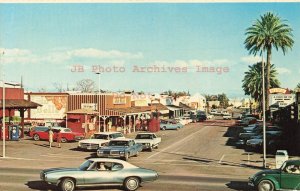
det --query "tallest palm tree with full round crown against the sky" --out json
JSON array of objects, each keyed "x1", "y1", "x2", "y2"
[{"x1": 244, "y1": 12, "x2": 294, "y2": 108}]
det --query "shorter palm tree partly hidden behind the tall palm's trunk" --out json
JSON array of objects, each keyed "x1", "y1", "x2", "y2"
[{"x1": 242, "y1": 62, "x2": 280, "y2": 109}]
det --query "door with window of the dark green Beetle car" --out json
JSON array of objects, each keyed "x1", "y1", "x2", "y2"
[{"x1": 280, "y1": 164, "x2": 300, "y2": 190}]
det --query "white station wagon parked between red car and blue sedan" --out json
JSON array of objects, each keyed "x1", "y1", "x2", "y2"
[{"x1": 78, "y1": 132, "x2": 125, "y2": 150}]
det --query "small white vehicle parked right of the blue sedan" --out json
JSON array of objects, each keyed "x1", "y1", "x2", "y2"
[{"x1": 135, "y1": 133, "x2": 161, "y2": 152}]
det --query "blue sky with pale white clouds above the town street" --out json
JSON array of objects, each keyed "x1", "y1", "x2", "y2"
[{"x1": 0, "y1": 3, "x2": 300, "y2": 97}]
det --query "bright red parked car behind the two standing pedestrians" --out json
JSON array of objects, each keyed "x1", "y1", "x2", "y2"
[{"x1": 29, "y1": 126, "x2": 84, "y2": 143}]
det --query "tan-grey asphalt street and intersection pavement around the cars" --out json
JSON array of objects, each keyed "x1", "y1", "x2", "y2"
[{"x1": 0, "y1": 120, "x2": 260, "y2": 191}]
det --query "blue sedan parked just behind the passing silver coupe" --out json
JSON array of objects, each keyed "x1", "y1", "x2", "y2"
[{"x1": 97, "y1": 139, "x2": 143, "y2": 161}]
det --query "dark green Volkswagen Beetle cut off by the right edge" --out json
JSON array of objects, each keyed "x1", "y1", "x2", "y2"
[{"x1": 248, "y1": 160, "x2": 300, "y2": 191}]
